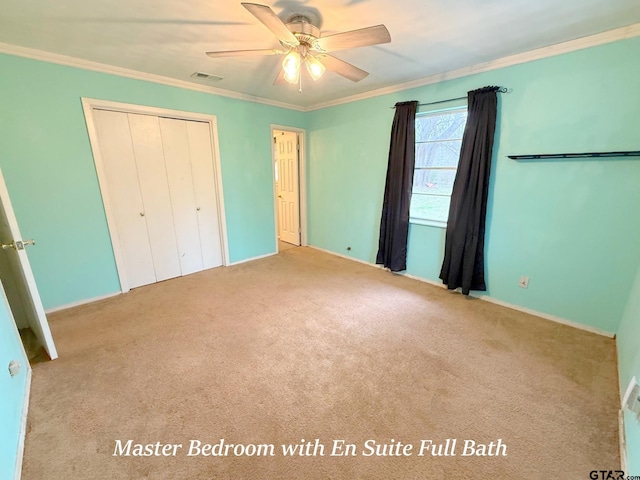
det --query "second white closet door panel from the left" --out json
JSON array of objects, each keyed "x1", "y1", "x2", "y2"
[{"x1": 129, "y1": 113, "x2": 181, "y2": 281}]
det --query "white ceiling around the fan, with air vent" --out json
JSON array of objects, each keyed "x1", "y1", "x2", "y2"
[{"x1": 0, "y1": 0, "x2": 640, "y2": 108}]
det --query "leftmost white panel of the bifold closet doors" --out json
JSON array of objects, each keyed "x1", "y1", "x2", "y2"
[{"x1": 94, "y1": 110, "x2": 156, "y2": 288}]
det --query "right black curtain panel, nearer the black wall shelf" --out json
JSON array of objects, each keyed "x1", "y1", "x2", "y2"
[{"x1": 440, "y1": 87, "x2": 499, "y2": 295}]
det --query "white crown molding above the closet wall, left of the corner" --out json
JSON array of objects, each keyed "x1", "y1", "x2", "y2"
[{"x1": 0, "y1": 42, "x2": 306, "y2": 112}]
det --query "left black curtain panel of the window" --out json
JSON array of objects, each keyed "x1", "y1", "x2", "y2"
[{"x1": 376, "y1": 101, "x2": 418, "y2": 272}]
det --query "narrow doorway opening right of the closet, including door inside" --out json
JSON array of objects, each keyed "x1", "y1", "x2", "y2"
[{"x1": 271, "y1": 125, "x2": 307, "y2": 252}]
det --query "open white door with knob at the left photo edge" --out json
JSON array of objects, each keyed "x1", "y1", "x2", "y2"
[{"x1": 0, "y1": 167, "x2": 58, "y2": 360}]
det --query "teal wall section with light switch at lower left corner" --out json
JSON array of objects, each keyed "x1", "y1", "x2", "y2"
[{"x1": 0, "y1": 287, "x2": 29, "y2": 479}]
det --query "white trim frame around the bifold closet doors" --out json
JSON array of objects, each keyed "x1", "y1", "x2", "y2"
[{"x1": 82, "y1": 97, "x2": 229, "y2": 293}]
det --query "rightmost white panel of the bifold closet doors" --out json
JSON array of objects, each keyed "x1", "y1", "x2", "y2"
[{"x1": 186, "y1": 122, "x2": 222, "y2": 268}]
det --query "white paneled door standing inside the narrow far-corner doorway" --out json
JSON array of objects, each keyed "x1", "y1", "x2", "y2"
[{"x1": 275, "y1": 131, "x2": 300, "y2": 245}]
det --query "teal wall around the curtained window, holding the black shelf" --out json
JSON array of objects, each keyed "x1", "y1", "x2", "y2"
[{"x1": 308, "y1": 38, "x2": 640, "y2": 333}]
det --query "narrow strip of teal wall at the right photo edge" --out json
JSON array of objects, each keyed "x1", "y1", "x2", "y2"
[{"x1": 617, "y1": 268, "x2": 640, "y2": 475}]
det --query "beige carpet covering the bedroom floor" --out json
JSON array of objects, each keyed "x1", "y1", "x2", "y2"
[{"x1": 23, "y1": 248, "x2": 620, "y2": 480}]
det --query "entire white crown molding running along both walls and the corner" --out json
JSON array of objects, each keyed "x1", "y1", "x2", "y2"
[{"x1": 0, "y1": 23, "x2": 640, "y2": 112}]
